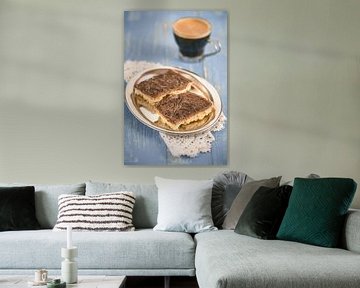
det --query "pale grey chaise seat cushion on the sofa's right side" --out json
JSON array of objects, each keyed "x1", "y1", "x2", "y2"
[{"x1": 195, "y1": 230, "x2": 360, "y2": 288}]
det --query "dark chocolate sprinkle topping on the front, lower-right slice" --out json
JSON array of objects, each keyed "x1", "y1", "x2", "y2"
[{"x1": 156, "y1": 92, "x2": 212, "y2": 124}]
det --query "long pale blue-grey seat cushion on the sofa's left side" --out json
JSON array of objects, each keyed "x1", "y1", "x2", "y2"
[{"x1": 0, "y1": 229, "x2": 195, "y2": 270}]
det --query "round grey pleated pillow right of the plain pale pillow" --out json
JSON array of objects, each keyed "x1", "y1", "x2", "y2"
[{"x1": 211, "y1": 171, "x2": 250, "y2": 228}]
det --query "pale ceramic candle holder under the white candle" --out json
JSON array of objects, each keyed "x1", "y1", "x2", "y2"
[{"x1": 61, "y1": 247, "x2": 78, "y2": 284}]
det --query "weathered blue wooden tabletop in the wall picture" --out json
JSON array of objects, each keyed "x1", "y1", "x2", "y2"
[{"x1": 124, "y1": 10, "x2": 228, "y2": 165}]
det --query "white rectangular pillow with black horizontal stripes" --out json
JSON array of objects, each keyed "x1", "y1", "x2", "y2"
[{"x1": 54, "y1": 192, "x2": 135, "y2": 231}]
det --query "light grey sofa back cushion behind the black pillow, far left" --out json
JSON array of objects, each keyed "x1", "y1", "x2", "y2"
[{"x1": 0, "y1": 183, "x2": 85, "y2": 229}]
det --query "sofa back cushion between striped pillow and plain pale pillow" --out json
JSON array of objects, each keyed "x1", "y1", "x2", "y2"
[{"x1": 85, "y1": 181, "x2": 158, "y2": 229}]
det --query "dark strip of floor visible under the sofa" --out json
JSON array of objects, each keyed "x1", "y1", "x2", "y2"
[{"x1": 126, "y1": 276, "x2": 199, "y2": 288}]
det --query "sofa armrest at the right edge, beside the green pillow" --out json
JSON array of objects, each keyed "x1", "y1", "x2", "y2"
[{"x1": 342, "y1": 209, "x2": 360, "y2": 253}]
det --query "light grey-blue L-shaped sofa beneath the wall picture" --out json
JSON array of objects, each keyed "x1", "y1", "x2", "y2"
[{"x1": 0, "y1": 173, "x2": 360, "y2": 288}]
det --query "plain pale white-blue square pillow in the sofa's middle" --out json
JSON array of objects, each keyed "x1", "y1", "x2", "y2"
[{"x1": 154, "y1": 177, "x2": 216, "y2": 233}]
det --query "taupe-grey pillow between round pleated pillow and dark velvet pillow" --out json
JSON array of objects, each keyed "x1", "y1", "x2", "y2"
[{"x1": 223, "y1": 176, "x2": 281, "y2": 230}]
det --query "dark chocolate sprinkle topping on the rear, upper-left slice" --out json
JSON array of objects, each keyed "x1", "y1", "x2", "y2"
[{"x1": 135, "y1": 70, "x2": 191, "y2": 98}]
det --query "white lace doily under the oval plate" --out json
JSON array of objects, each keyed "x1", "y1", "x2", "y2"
[{"x1": 124, "y1": 60, "x2": 226, "y2": 157}]
